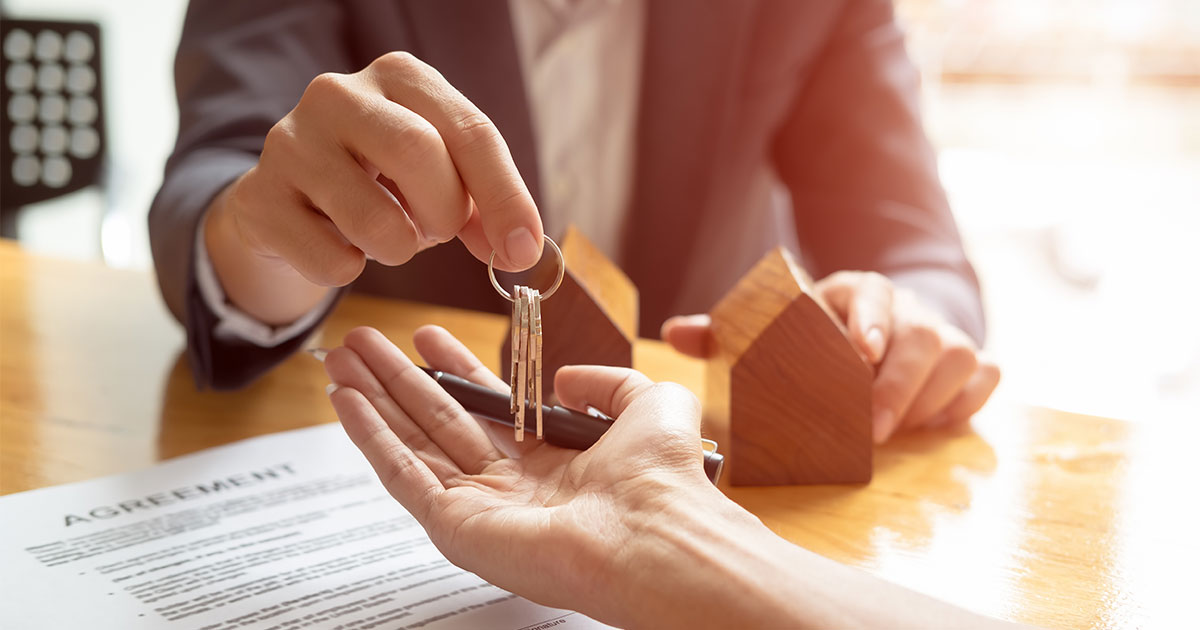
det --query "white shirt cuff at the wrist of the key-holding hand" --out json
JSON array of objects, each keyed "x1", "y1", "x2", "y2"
[{"x1": 194, "y1": 215, "x2": 337, "y2": 348}]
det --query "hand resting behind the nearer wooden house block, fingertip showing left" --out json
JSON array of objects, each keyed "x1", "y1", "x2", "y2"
[{"x1": 662, "y1": 271, "x2": 1000, "y2": 443}]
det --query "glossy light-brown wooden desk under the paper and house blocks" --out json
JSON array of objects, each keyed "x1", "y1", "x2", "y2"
[{"x1": 0, "y1": 242, "x2": 1200, "y2": 628}]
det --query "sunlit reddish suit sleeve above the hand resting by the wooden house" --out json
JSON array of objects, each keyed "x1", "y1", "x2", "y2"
[{"x1": 774, "y1": 0, "x2": 984, "y2": 343}]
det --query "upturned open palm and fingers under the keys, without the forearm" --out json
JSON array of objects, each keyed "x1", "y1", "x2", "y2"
[{"x1": 325, "y1": 326, "x2": 720, "y2": 619}]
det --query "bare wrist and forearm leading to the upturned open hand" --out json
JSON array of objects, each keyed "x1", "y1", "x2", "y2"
[{"x1": 595, "y1": 487, "x2": 1001, "y2": 628}]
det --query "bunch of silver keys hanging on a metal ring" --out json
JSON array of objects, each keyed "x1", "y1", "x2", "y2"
[{"x1": 487, "y1": 236, "x2": 566, "y2": 442}]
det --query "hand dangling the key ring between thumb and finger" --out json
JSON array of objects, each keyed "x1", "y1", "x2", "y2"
[{"x1": 205, "y1": 53, "x2": 542, "y2": 323}]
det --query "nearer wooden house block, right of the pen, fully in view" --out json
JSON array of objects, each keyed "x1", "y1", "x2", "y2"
[{"x1": 706, "y1": 247, "x2": 874, "y2": 486}]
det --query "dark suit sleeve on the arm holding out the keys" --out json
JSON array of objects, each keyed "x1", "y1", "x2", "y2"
[{"x1": 149, "y1": 0, "x2": 350, "y2": 389}]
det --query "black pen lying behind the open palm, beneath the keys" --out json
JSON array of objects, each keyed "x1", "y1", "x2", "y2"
[{"x1": 307, "y1": 348, "x2": 725, "y2": 484}]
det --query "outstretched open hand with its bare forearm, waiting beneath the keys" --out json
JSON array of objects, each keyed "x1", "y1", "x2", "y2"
[{"x1": 325, "y1": 326, "x2": 1012, "y2": 628}]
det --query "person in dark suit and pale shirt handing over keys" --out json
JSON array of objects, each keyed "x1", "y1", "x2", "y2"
[{"x1": 150, "y1": 0, "x2": 1000, "y2": 440}]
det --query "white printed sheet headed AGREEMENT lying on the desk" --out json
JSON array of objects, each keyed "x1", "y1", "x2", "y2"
[{"x1": 0, "y1": 424, "x2": 606, "y2": 630}]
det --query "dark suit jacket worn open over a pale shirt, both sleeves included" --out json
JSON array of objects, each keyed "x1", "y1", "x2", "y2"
[{"x1": 150, "y1": 0, "x2": 983, "y2": 388}]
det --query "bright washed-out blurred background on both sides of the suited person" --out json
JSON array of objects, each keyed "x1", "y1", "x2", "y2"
[{"x1": 2, "y1": 0, "x2": 1200, "y2": 421}]
